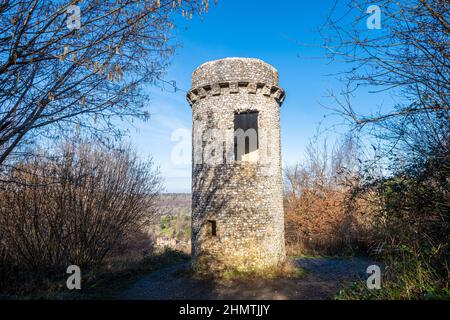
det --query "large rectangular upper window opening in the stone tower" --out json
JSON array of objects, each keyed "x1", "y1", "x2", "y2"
[{"x1": 234, "y1": 112, "x2": 259, "y2": 161}]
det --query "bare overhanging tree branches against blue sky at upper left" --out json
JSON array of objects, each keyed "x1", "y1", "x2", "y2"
[{"x1": 0, "y1": 0, "x2": 208, "y2": 165}]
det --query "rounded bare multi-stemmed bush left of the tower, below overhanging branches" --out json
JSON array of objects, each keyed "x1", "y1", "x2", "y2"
[{"x1": 0, "y1": 140, "x2": 161, "y2": 275}]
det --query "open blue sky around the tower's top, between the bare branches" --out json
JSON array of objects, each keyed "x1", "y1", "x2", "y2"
[{"x1": 124, "y1": 0, "x2": 390, "y2": 192}]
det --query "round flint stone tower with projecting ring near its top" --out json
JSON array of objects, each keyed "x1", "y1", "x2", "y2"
[{"x1": 187, "y1": 58, "x2": 285, "y2": 271}]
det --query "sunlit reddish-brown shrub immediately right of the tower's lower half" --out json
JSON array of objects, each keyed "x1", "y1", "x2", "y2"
[{"x1": 285, "y1": 139, "x2": 372, "y2": 255}]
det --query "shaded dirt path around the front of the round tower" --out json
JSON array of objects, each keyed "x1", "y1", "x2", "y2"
[{"x1": 117, "y1": 258, "x2": 374, "y2": 300}]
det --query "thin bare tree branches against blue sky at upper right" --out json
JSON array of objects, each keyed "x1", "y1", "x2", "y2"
[{"x1": 321, "y1": 0, "x2": 450, "y2": 157}]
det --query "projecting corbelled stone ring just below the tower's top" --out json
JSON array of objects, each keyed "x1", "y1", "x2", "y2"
[{"x1": 186, "y1": 81, "x2": 286, "y2": 106}]
